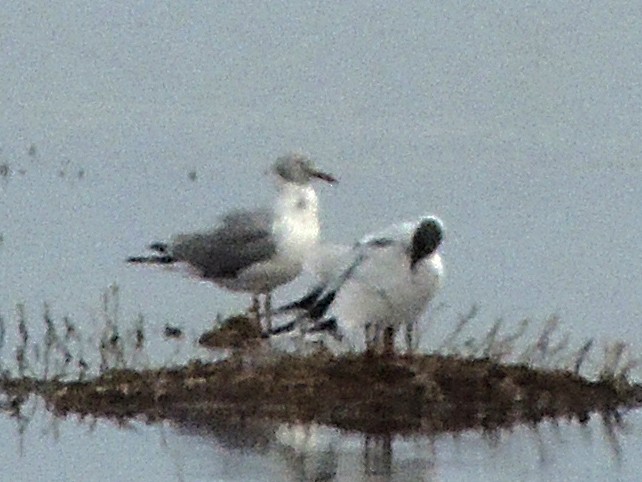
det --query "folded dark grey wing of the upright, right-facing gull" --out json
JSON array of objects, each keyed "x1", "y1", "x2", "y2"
[{"x1": 171, "y1": 209, "x2": 277, "y2": 279}]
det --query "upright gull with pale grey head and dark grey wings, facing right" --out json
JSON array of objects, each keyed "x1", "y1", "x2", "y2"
[{"x1": 127, "y1": 154, "x2": 337, "y2": 330}]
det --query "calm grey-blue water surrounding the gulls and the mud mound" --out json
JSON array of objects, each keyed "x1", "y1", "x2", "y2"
[{"x1": 0, "y1": 2, "x2": 642, "y2": 480}]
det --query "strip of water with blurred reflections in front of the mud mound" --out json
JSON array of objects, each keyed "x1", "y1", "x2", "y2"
[{"x1": 0, "y1": 397, "x2": 642, "y2": 482}]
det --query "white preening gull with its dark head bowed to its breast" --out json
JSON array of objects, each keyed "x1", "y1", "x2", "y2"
[{"x1": 271, "y1": 216, "x2": 444, "y2": 353}]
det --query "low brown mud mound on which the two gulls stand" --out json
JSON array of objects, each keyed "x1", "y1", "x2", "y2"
[{"x1": 20, "y1": 354, "x2": 642, "y2": 433}]
